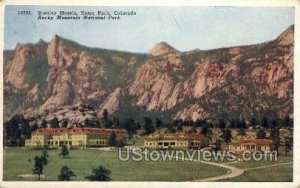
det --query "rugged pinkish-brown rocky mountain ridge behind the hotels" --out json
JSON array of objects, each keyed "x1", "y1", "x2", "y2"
[{"x1": 3, "y1": 26, "x2": 294, "y2": 128}]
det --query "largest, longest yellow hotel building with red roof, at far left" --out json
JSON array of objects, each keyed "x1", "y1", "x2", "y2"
[{"x1": 25, "y1": 128, "x2": 127, "y2": 148}]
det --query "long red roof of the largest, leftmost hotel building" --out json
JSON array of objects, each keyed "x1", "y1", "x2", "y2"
[{"x1": 33, "y1": 128, "x2": 126, "y2": 134}]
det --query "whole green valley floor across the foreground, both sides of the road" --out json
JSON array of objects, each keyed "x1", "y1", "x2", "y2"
[{"x1": 3, "y1": 148, "x2": 293, "y2": 182}]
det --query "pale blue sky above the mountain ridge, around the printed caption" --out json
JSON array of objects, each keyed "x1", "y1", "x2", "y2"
[{"x1": 4, "y1": 6, "x2": 294, "y2": 53}]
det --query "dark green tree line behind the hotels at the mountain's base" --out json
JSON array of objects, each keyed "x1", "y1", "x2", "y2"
[{"x1": 4, "y1": 109, "x2": 293, "y2": 146}]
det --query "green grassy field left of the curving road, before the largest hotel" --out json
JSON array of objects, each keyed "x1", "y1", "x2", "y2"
[{"x1": 3, "y1": 148, "x2": 227, "y2": 181}]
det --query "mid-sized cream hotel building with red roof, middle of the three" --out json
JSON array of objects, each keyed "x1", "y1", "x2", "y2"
[{"x1": 144, "y1": 133, "x2": 209, "y2": 149}]
